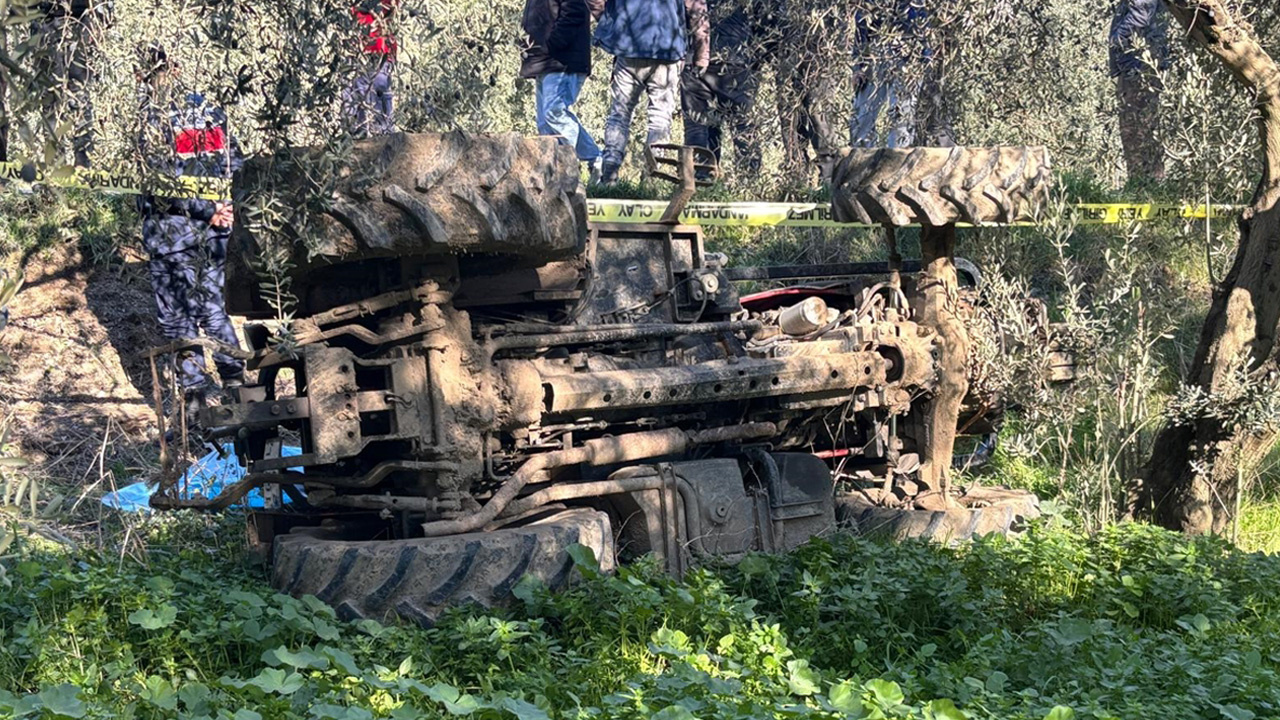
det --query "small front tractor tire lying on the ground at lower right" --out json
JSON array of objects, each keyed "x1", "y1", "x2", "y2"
[{"x1": 836, "y1": 491, "x2": 1041, "y2": 544}]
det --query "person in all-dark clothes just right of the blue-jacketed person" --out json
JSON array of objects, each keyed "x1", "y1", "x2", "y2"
[{"x1": 680, "y1": 0, "x2": 768, "y2": 173}]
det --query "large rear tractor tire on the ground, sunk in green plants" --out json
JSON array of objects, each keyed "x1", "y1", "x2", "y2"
[{"x1": 271, "y1": 509, "x2": 614, "y2": 625}]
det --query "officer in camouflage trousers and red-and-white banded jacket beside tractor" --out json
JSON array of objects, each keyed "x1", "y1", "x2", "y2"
[{"x1": 138, "y1": 46, "x2": 244, "y2": 407}]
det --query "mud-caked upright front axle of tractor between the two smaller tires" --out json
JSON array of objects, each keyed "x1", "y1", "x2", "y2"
[{"x1": 916, "y1": 225, "x2": 969, "y2": 510}]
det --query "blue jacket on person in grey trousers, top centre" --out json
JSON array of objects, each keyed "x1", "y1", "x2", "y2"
[{"x1": 595, "y1": 0, "x2": 710, "y2": 68}]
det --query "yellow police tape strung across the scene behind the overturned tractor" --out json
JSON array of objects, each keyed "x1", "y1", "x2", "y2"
[{"x1": 0, "y1": 163, "x2": 1239, "y2": 228}]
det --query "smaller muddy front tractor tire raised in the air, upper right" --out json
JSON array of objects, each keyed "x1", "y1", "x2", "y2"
[{"x1": 831, "y1": 146, "x2": 1051, "y2": 225}]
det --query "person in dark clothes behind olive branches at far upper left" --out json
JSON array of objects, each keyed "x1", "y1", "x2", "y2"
[{"x1": 32, "y1": 0, "x2": 111, "y2": 168}]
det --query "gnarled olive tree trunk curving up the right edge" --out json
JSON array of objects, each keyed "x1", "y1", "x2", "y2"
[{"x1": 1132, "y1": 0, "x2": 1280, "y2": 533}]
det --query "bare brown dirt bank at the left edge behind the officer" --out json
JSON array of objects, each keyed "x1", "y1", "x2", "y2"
[{"x1": 0, "y1": 241, "x2": 160, "y2": 481}]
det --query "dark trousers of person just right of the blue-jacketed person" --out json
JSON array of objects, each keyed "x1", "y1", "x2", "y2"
[{"x1": 680, "y1": 63, "x2": 762, "y2": 173}]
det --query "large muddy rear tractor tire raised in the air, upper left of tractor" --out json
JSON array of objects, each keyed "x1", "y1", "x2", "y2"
[{"x1": 227, "y1": 132, "x2": 588, "y2": 303}]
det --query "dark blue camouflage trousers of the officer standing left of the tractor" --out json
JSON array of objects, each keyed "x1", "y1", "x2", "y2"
[{"x1": 148, "y1": 229, "x2": 244, "y2": 389}]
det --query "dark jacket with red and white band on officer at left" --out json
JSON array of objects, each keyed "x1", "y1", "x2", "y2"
[{"x1": 138, "y1": 92, "x2": 243, "y2": 255}]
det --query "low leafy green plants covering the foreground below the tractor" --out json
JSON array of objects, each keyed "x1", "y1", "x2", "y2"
[{"x1": 0, "y1": 516, "x2": 1280, "y2": 720}]
